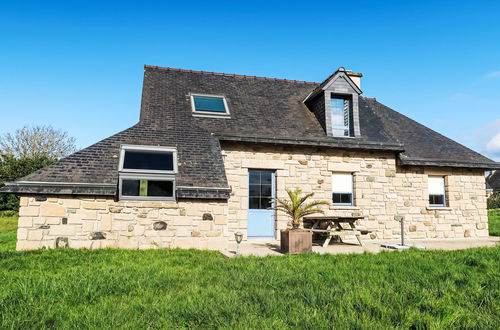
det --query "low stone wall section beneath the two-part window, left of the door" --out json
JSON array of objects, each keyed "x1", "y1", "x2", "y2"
[{"x1": 17, "y1": 196, "x2": 229, "y2": 250}]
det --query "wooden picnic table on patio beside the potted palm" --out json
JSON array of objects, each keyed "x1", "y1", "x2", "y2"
[{"x1": 304, "y1": 216, "x2": 364, "y2": 247}]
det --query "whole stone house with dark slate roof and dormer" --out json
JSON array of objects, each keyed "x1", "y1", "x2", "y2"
[{"x1": 1, "y1": 66, "x2": 500, "y2": 250}]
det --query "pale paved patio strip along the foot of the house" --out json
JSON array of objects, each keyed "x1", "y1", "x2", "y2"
[{"x1": 221, "y1": 236, "x2": 500, "y2": 257}]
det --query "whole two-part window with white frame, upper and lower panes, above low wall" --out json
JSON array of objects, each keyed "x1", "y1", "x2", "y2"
[{"x1": 119, "y1": 145, "x2": 177, "y2": 200}]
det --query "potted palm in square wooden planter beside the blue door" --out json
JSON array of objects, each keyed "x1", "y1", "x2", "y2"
[{"x1": 276, "y1": 188, "x2": 330, "y2": 253}]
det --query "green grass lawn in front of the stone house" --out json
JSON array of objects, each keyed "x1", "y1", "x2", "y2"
[{"x1": 0, "y1": 214, "x2": 500, "y2": 329}]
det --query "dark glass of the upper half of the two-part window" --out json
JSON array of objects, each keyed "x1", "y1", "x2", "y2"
[{"x1": 123, "y1": 150, "x2": 174, "y2": 171}]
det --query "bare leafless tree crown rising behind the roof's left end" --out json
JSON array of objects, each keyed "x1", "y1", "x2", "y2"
[{"x1": 0, "y1": 126, "x2": 76, "y2": 159}]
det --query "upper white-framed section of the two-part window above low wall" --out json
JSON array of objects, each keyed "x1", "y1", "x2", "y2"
[{"x1": 120, "y1": 145, "x2": 177, "y2": 174}]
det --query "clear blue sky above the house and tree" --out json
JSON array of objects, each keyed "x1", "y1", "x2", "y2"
[{"x1": 0, "y1": 0, "x2": 500, "y2": 160}]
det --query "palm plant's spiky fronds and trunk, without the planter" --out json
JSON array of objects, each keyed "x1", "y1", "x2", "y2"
[{"x1": 276, "y1": 188, "x2": 330, "y2": 229}]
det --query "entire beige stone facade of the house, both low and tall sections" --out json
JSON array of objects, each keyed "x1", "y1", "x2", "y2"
[{"x1": 17, "y1": 144, "x2": 488, "y2": 249}]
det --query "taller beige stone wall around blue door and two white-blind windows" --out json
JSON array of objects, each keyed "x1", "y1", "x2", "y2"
[{"x1": 223, "y1": 144, "x2": 488, "y2": 239}]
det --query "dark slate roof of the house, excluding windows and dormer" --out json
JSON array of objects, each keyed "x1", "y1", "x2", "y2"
[{"x1": 1, "y1": 66, "x2": 500, "y2": 198}]
